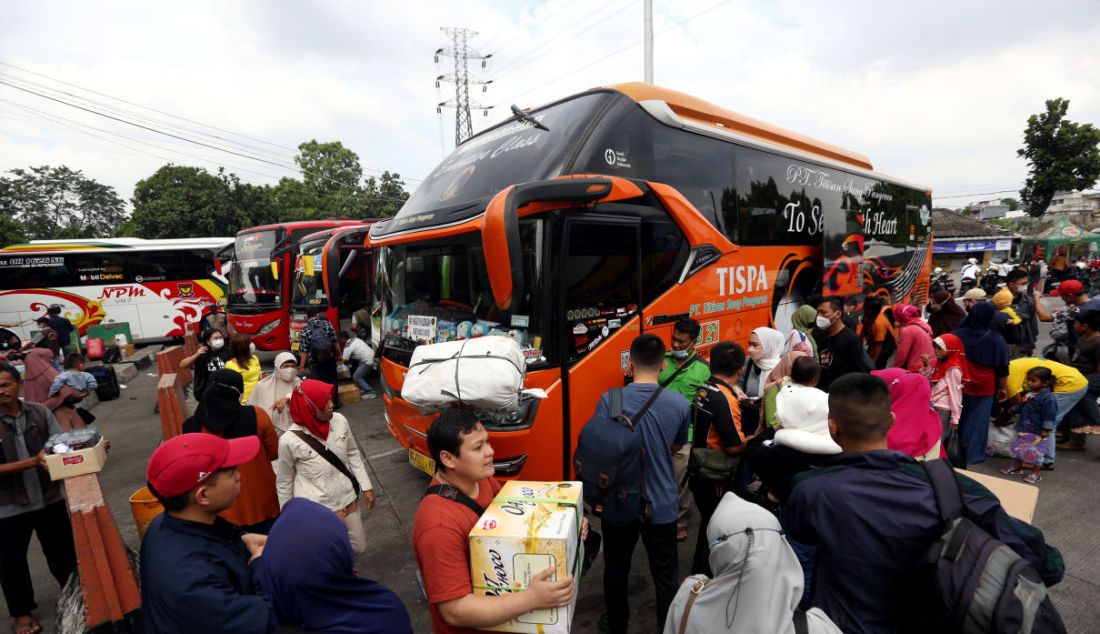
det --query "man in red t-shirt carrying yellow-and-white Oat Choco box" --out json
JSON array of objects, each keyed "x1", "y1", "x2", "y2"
[{"x1": 413, "y1": 409, "x2": 587, "y2": 634}]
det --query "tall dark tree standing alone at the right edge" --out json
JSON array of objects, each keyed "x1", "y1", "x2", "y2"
[{"x1": 1016, "y1": 98, "x2": 1100, "y2": 217}]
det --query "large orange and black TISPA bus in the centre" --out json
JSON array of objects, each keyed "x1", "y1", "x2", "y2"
[{"x1": 370, "y1": 84, "x2": 932, "y2": 480}]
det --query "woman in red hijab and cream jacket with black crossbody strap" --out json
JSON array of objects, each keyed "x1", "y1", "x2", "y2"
[{"x1": 275, "y1": 379, "x2": 374, "y2": 556}]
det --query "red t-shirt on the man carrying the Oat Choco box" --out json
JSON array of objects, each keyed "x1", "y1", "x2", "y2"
[{"x1": 413, "y1": 478, "x2": 502, "y2": 634}]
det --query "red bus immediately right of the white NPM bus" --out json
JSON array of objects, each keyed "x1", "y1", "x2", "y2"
[{"x1": 226, "y1": 219, "x2": 363, "y2": 350}]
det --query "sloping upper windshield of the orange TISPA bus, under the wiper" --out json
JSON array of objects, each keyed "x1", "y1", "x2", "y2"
[{"x1": 389, "y1": 92, "x2": 613, "y2": 222}]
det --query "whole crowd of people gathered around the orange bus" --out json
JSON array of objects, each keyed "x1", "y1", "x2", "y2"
[{"x1": 0, "y1": 278, "x2": 1082, "y2": 634}]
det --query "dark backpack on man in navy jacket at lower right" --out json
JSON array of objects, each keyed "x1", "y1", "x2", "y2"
[{"x1": 908, "y1": 460, "x2": 1066, "y2": 634}]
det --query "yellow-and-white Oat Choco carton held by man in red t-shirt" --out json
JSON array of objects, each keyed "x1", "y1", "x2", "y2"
[{"x1": 470, "y1": 481, "x2": 584, "y2": 634}]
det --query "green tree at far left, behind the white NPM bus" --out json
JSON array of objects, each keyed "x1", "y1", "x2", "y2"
[{"x1": 0, "y1": 165, "x2": 127, "y2": 240}]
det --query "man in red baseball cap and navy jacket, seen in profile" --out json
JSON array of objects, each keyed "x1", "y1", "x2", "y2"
[{"x1": 141, "y1": 434, "x2": 278, "y2": 634}]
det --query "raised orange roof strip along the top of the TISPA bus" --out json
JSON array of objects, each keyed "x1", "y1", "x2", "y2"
[{"x1": 608, "y1": 81, "x2": 875, "y2": 171}]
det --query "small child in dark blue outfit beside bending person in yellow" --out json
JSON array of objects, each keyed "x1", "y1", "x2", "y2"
[{"x1": 1001, "y1": 368, "x2": 1058, "y2": 484}]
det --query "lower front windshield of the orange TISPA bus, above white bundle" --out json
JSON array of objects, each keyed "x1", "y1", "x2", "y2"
[{"x1": 376, "y1": 220, "x2": 542, "y2": 358}]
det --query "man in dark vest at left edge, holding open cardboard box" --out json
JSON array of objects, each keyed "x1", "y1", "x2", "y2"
[{"x1": 0, "y1": 363, "x2": 76, "y2": 634}]
